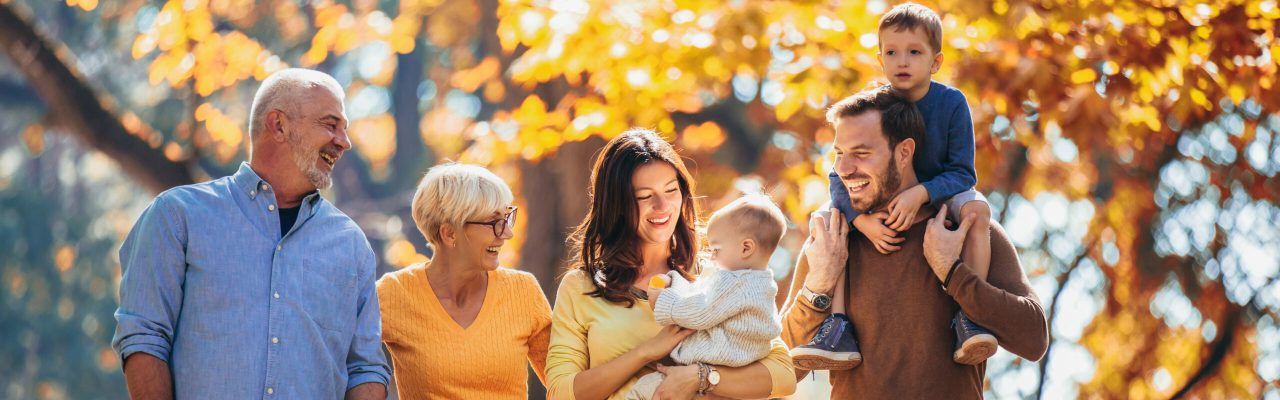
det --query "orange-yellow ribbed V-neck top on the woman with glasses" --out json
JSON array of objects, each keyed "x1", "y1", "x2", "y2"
[{"x1": 378, "y1": 263, "x2": 552, "y2": 399}]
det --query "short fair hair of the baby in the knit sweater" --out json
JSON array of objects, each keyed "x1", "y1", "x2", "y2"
[{"x1": 707, "y1": 194, "x2": 787, "y2": 254}]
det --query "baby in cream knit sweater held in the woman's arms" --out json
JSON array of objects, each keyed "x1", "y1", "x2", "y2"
[{"x1": 626, "y1": 195, "x2": 786, "y2": 399}]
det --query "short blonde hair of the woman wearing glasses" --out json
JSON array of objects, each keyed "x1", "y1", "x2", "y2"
[{"x1": 413, "y1": 163, "x2": 513, "y2": 246}]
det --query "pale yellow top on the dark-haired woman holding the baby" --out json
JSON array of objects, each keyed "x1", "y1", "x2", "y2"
[{"x1": 547, "y1": 269, "x2": 796, "y2": 400}]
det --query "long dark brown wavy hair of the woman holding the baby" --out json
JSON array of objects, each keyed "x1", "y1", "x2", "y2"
[{"x1": 570, "y1": 128, "x2": 699, "y2": 308}]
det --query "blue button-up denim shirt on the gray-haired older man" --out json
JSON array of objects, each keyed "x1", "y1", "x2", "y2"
[{"x1": 111, "y1": 163, "x2": 389, "y2": 399}]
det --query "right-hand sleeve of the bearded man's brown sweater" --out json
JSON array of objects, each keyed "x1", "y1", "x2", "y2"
[{"x1": 942, "y1": 222, "x2": 1048, "y2": 362}]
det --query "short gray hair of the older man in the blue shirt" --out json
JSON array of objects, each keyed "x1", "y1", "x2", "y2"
[{"x1": 248, "y1": 68, "x2": 344, "y2": 138}]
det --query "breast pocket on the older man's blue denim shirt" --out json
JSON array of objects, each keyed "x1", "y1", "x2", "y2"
[{"x1": 294, "y1": 256, "x2": 357, "y2": 332}]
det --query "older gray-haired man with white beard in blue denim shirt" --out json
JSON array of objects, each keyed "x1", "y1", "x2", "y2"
[{"x1": 113, "y1": 69, "x2": 389, "y2": 399}]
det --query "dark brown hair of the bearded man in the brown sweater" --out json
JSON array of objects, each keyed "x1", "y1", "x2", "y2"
[{"x1": 827, "y1": 85, "x2": 924, "y2": 153}]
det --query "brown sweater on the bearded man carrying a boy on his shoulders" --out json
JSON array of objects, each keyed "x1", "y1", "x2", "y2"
[{"x1": 782, "y1": 222, "x2": 1048, "y2": 399}]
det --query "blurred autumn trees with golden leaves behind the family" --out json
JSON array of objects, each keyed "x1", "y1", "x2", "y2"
[{"x1": 0, "y1": 0, "x2": 1280, "y2": 399}]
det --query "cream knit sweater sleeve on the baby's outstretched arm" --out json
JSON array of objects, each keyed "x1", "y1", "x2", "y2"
[{"x1": 653, "y1": 273, "x2": 753, "y2": 331}]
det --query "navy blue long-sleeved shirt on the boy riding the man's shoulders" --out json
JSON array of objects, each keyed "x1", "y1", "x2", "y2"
[{"x1": 827, "y1": 82, "x2": 978, "y2": 222}]
